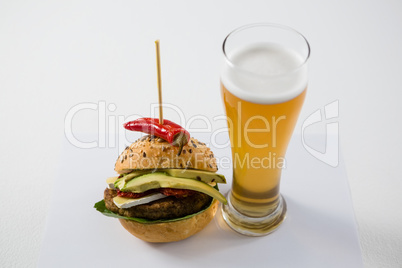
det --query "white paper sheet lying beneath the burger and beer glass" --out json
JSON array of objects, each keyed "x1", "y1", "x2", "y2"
[{"x1": 38, "y1": 133, "x2": 363, "y2": 268}]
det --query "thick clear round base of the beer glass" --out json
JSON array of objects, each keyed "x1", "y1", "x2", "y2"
[{"x1": 222, "y1": 192, "x2": 286, "y2": 236}]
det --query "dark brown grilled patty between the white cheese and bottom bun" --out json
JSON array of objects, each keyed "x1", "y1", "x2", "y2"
[{"x1": 104, "y1": 188, "x2": 212, "y2": 220}]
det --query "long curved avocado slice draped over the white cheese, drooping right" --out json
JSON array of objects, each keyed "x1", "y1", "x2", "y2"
[{"x1": 121, "y1": 172, "x2": 227, "y2": 204}]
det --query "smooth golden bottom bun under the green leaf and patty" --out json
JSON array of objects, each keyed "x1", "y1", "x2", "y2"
[{"x1": 119, "y1": 199, "x2": 219, "y2": 243}]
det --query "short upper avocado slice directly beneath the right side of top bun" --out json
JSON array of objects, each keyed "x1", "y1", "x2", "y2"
[{"x1": 163, "y1": 169, "x2": 226, "y2": 183}]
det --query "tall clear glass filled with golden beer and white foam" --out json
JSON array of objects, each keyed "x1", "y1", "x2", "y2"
[{"x1": 221, "y1": 23, "x2": 310, "y2": 236}]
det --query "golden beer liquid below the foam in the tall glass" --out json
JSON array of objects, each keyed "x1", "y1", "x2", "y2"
[{"x1": 221, "y1": 84, "x2": 306, "y2": 217}]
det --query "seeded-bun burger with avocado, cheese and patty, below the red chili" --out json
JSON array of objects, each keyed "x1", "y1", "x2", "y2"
[{"x1": 95, "y1": 135, "x2": 227, "y2": 242}]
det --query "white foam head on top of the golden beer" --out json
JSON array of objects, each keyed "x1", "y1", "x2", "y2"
[{"x1": 221, "y1": 43, "x2": 307, "y2": 104}]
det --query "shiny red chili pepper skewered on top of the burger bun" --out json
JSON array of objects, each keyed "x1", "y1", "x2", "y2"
[{"x1": 123, "y1": 118, "x2": 190, "y2": 155}]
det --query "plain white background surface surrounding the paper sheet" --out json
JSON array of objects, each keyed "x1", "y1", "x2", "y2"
[{"x1": 0, "y1": 0, "x2": 402, "y2": 267}]
